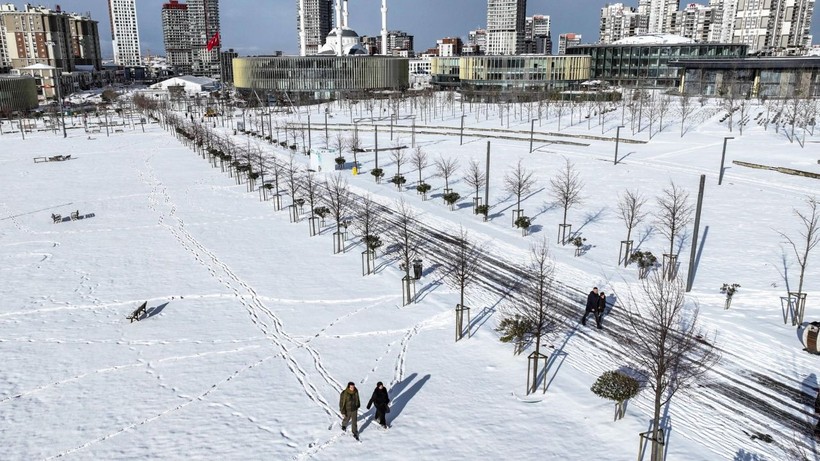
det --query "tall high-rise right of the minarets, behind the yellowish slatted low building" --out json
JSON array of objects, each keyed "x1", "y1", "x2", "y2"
[{"x1": 486, "y1": 0, "x2": 527, "y2": 55}]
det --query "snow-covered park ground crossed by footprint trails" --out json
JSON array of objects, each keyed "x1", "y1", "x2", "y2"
[{"x1": 0, "y1": 94, "x2": 820, "y2": 460}]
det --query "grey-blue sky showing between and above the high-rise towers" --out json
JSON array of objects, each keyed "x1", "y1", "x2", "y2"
[{"x1": 43, "y1": 0, "x2": 820, "y2": 58}]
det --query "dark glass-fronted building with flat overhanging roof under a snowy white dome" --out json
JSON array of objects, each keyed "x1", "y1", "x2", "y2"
[{"x1": 567, "y1": 43, "x2": 748, "y2": 88}]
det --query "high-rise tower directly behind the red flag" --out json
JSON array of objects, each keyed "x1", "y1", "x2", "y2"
[{"x1": 188, "y1": 0, "x2": 222, "y2": 79}]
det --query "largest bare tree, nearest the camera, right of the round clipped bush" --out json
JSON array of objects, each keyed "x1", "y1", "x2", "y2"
[{"x1": 620, "y1": 272, "x2": 720, "y2": 461}]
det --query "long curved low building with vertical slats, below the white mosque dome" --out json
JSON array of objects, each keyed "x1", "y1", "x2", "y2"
[{"x1": 233, "y1": 56, "x2": 410, "y2": 101}]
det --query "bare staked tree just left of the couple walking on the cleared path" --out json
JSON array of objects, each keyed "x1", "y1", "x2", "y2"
[{"x1": 497, "y1": 240, "x2": 565, "y2": 393}]
